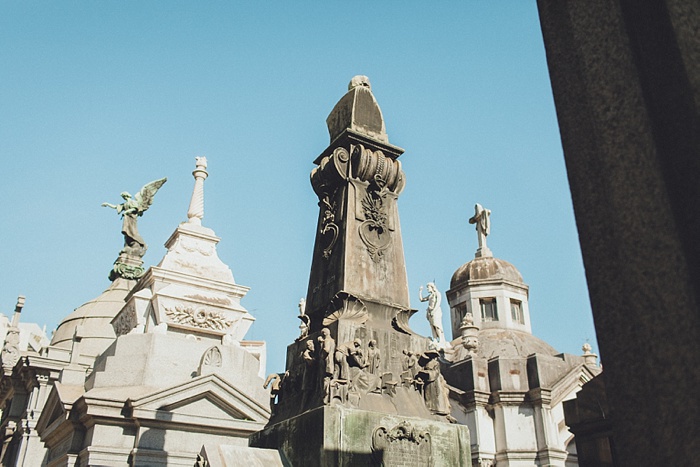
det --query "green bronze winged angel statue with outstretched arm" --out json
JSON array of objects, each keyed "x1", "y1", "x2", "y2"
[{"x1": 102, "y1": 178, "x2": 168, "y2": 257}]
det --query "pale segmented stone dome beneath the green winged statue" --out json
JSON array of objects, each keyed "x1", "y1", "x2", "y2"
[{"x1": 51, "y1": 277, "x2": 136, "y2": 356}]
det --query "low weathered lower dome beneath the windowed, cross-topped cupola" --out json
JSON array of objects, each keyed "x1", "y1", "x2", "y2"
[{"x1": 478, "y1": 329, "x2": 561, "y2": 358}]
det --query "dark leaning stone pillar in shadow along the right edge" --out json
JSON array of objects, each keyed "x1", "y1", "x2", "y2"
[{"x1": 538, "y1": 0, "x2": 700, "y2": 465}]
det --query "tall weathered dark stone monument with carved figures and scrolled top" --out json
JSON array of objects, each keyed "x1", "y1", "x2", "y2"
[{"x1": 250, "y1": 76, "x2": 471, "y2": 466}]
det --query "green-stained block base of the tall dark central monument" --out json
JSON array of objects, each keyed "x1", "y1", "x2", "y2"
[{"x1": 249, "y1": 406, "x2": 471, "y2": 467}]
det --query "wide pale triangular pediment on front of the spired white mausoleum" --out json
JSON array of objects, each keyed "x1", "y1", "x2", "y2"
[{"x1": 127, "y1": 374, "x2": 270, "y2": 425}]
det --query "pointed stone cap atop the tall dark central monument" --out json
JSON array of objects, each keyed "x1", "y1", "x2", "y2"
[{"x1": 326, "y1": 75, "x2": 389, "y2": 143}]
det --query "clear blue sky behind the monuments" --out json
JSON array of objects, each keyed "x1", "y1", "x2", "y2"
[{"x1": 0, "y1": 0, "x2": 597, "y2": 371}]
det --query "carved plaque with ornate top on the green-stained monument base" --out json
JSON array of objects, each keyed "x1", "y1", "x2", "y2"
[{"x1": 372, "y1": 421, "x2": 433, "y2": 467}]
